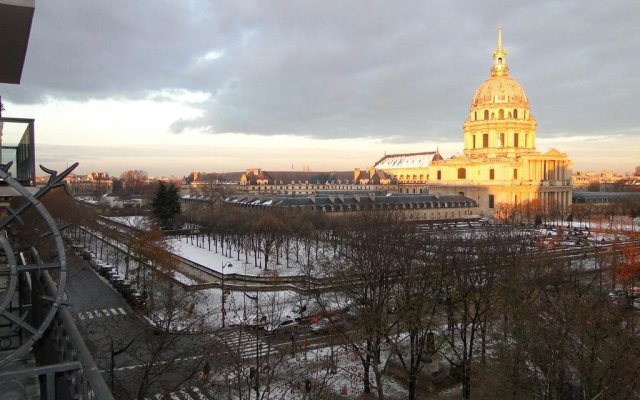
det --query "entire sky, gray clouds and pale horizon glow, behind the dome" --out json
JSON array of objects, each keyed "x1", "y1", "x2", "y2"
[{"x1": 0, "y1": 0, "x2": 640, "y2": 176}]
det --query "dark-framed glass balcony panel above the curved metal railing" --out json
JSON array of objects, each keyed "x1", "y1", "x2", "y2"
[{"x1": 0, "y1": 117, "x2": 36, "y2": 186}]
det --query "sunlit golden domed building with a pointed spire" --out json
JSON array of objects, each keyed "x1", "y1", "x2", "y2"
[{"x1": 374, "y1": 28, "x2": 571, "y2": 216}]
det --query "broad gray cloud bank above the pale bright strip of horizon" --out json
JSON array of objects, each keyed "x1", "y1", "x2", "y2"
[{"x1": 0, "y1": 0, "x2": 640, "y2": 141}]
